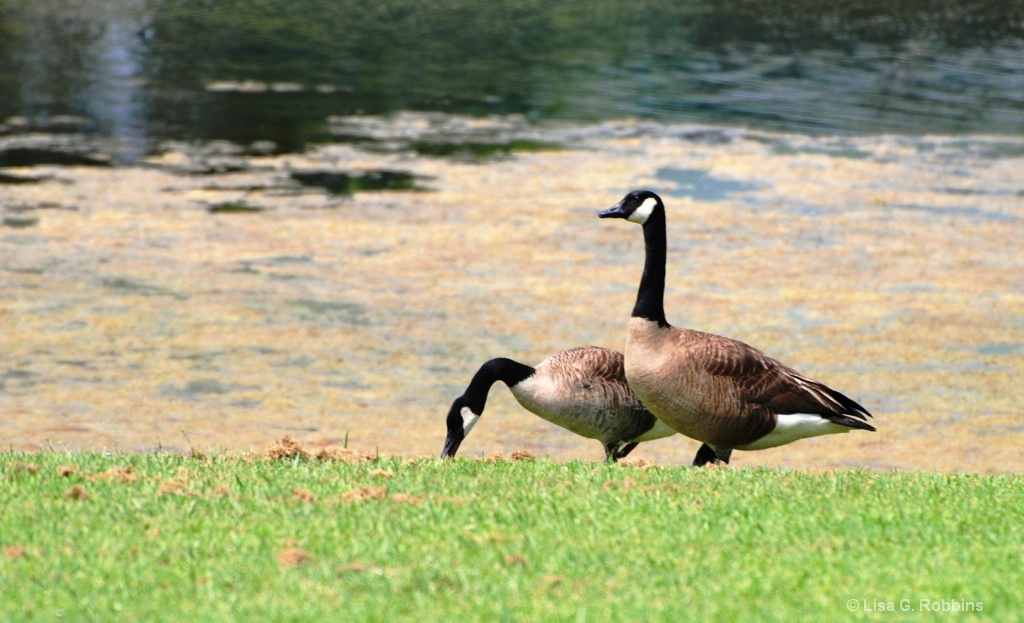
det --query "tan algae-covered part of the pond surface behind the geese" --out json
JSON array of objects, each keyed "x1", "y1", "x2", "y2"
[{"x1": 0, "y1": 120, "x2": 1024, "y2": 472}]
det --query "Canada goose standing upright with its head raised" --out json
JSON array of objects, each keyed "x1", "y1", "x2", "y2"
[{"x1": 599, "y1": 191, "x2": 874, "y2": 463}]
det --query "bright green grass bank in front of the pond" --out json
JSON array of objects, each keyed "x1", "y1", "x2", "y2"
[{"x1": 0, "y1": 452, "x2": 1024, "y2": 621}]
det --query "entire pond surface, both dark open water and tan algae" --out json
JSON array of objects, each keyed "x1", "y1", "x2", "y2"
[{"x1": 0, "y1": 0, "x2": 1024, "y2": 471}]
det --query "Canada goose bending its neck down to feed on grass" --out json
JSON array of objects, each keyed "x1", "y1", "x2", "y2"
[{"x1": 441, "y1": 346, "x2": 714, "y2": 464}]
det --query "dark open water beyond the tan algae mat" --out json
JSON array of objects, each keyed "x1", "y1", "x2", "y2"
[{"x1": 0, "y1": 0, "x2": 1024, "y2": 160}]
